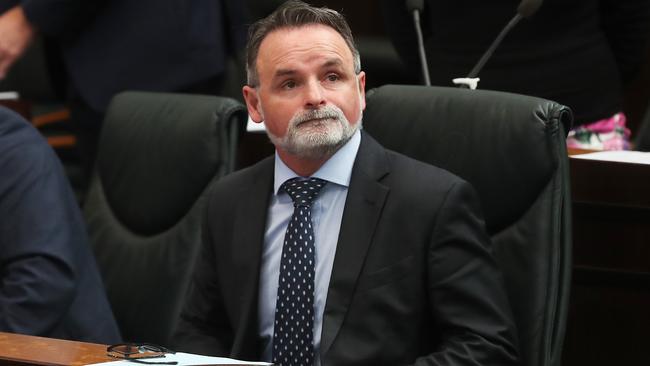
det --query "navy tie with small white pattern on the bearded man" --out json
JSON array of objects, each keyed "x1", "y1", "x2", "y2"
[{"x1": 273, "y1": 178, "x2": 327, "y2": 366}]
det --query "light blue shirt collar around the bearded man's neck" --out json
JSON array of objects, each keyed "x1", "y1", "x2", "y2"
[{"x1": 273, "y1": 130, "x2": 361, "y2": 194}]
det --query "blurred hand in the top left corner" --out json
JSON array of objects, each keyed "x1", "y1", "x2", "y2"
[{"x1": 0, "y1": 5, "x2": 35, "y2": 79}]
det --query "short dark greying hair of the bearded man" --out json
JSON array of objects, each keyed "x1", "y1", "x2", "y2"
[{"x1": 246, "y1": 0, "x2": 361, "y2": 87}]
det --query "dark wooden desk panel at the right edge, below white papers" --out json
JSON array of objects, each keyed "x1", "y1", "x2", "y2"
[{"x1": 563, "y1": 158, "x2": 650, "y2": 366}]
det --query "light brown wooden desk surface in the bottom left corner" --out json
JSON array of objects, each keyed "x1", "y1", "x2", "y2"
[{"x1": 0, "y1": 332, "x2": 110, "y2": 366}]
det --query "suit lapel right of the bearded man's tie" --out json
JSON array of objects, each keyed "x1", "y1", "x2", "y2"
[{"x1": 320, "y1": 133, "x2": 389, "y2": 359}]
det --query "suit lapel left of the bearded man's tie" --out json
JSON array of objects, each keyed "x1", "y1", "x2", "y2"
[{"x1": 230, "y1": 158, "x2": 273, "y2": 358}]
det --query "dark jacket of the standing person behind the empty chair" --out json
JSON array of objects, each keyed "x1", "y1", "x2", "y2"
[{"x1": 0, "y1": 0, "x2": 245, "y2": 112}]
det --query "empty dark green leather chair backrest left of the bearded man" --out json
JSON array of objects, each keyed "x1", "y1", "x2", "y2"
[{"x1": 84, "y1": 92, "x2": 246, "y2": 345}]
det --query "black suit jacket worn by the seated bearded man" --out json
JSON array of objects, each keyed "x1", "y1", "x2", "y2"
[{"x1": 177, "y1": 133, "x2": 517, "y2": 365}]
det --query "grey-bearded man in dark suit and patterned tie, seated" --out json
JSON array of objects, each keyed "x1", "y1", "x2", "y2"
[{"x1": 176, "y1": 1, "x2": 517, "y2": 366}]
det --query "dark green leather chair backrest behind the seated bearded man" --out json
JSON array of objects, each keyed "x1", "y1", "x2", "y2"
[{"x1": 363, "y1": 85, "x2": 572, "y2": 366}]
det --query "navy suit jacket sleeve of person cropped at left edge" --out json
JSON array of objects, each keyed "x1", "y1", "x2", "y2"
[{"x1": 0, "y1": 107, "x2": 120, "y2": 344}]
